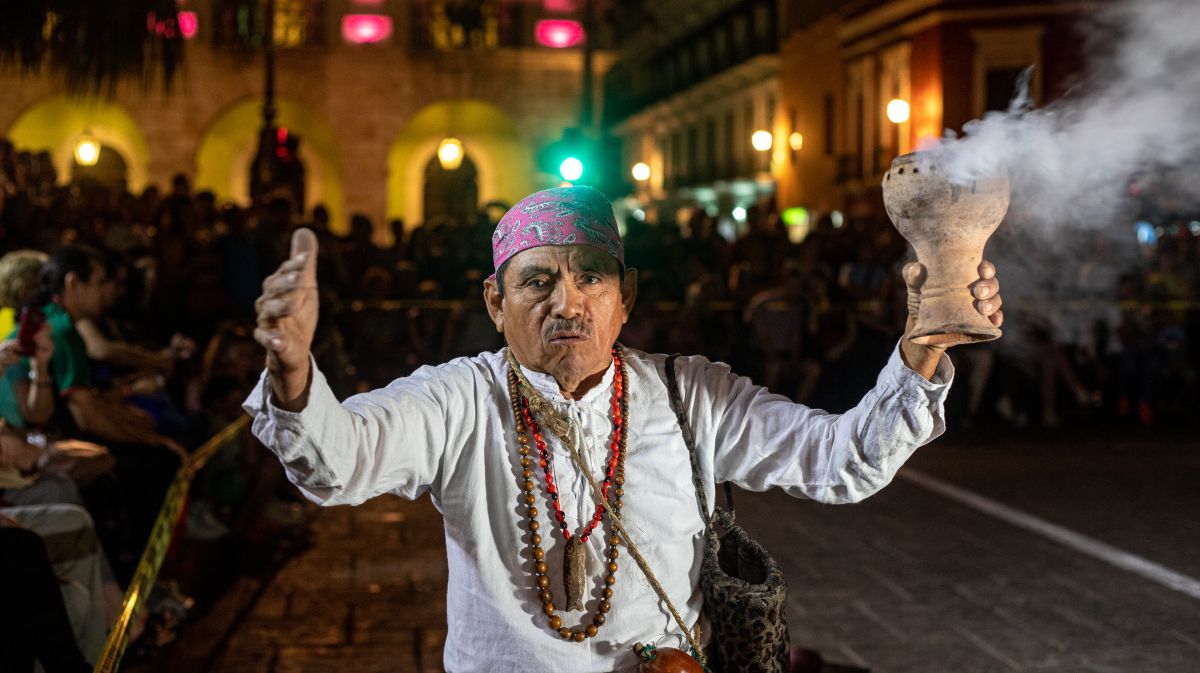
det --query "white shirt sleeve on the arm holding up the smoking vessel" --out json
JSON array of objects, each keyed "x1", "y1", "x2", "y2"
[{"x1": 679, "y1": 345, "x2": 954, "y2": 504}]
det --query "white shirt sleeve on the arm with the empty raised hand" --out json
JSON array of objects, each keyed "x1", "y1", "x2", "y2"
[{"x1": 242, "y1": 361, "x2": 475, "y2": 505}]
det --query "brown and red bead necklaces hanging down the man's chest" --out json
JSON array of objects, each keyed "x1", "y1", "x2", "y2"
[{"x1": 509, "y1": 345, "x2": 629, "y2": 643}]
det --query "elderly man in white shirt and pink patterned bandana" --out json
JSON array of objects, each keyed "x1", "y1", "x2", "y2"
[{"x1": 245, "y1": 187, "x2": 1002, "y2": 673}]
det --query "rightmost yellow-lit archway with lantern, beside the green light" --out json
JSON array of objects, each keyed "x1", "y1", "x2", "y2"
[{"x1": 388, "y1": 100, "x2": 535, "y2": 229}]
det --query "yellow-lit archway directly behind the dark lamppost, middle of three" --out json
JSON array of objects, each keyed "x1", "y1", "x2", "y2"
[{"x1": 196, "y1": 97, "x2": 348, "y2": 232}]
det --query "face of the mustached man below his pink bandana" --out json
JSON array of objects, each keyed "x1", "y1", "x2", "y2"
[{"x1": 484, "y1": 246, "x2": 637, "y2": 392}]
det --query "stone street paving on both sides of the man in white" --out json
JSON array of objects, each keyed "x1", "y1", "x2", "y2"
[{"x1": 212, "y1": 431, "x2": 1200, "y2": 673}]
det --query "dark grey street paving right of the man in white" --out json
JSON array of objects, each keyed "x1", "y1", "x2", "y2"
[{"x1": 736, "y1": 436, "x2": 1200, "y2": 673}]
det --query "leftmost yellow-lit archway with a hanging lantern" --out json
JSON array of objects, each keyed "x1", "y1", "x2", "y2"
[{"x1": 6, "y1": 96, "x2": 150, "y2": 193}]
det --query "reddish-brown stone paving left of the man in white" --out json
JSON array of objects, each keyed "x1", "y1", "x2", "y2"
[{"x1": 212, "y1": 495, "x2": 446, "y2": 673}]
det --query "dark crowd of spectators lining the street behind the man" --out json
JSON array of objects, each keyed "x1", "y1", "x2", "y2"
[{"x1": 0, "y1": 132, "x2": 1200, "y2": 673}]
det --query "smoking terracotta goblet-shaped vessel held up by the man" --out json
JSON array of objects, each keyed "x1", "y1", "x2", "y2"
[{"x1": 883, "y1": 152, "x2": 1009, "y2": 345}]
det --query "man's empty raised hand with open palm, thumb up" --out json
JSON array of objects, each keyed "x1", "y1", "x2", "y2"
[{"x1": 254, "y1": 229, "x2": 319, "y2": 411}]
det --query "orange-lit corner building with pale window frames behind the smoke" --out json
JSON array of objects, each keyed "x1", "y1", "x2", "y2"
[{"x1": 775, "y1": 0, "x2": 1086, "y2": 223}]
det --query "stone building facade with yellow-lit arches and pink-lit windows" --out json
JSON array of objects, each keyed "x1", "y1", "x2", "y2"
[{"x1": 0, "y1": 0, "x2": 612, "y2": 235}]
